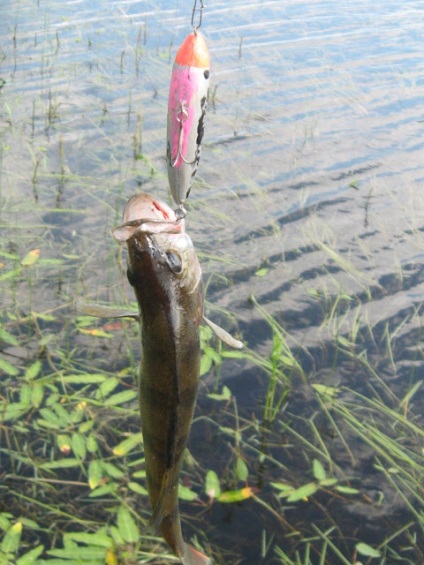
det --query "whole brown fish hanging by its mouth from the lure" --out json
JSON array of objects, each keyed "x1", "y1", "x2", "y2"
[{"x1": 79, "y1": 194, "x2": 243, "y2": 565}]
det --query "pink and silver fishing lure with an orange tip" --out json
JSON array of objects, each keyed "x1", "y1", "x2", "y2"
[{"x1": 166, "y1": 30, "x2": 210, "y2": 206}]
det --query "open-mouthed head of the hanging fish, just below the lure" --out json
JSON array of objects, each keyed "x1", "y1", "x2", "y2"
[{"x1": 112, "y1": 193, "x2": 202, "y2": 306}]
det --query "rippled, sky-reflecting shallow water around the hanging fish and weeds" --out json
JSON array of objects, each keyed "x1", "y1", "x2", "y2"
[{"x1": 0, "y1": 0, "x2": 424, "y2": 565}]
